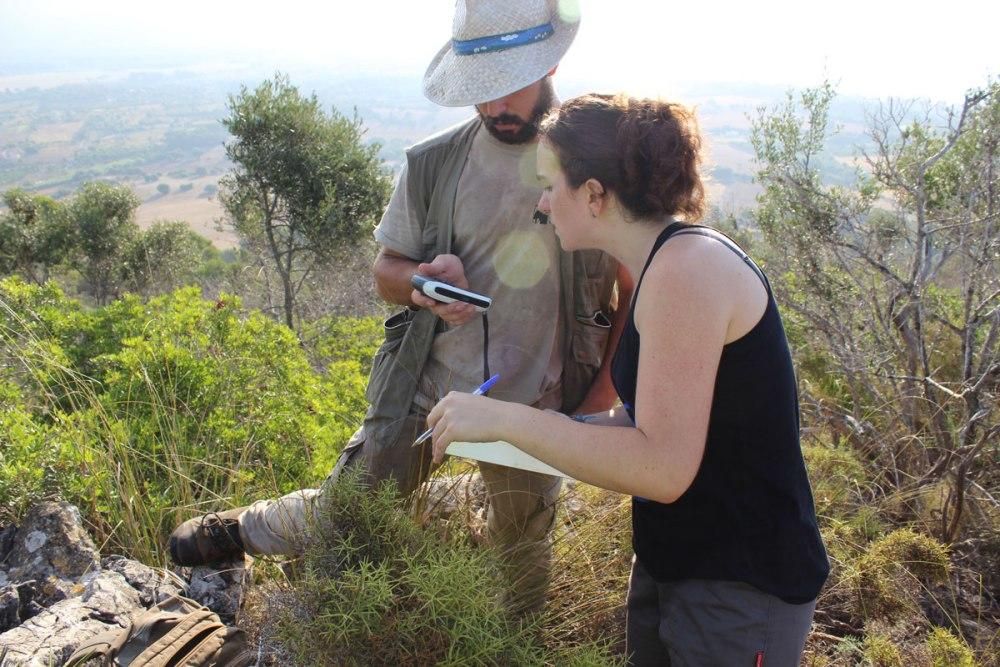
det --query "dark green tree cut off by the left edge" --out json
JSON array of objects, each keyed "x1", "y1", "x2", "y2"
[{"x1": 0, "y1": 188, "x2": 73, "y2": 284}]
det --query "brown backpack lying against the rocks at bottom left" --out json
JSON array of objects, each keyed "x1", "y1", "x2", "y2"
[{"x1": 66, "y1": 595, "x2": 255, "y2": 667}]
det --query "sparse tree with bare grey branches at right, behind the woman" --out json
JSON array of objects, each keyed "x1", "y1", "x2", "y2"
[{"x1": 752, "y1": 84, "x2": 1000, "y2": 541}]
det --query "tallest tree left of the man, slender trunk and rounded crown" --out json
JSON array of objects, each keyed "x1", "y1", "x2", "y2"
[{"x1": 220, "y1": 74, "x2": 389, "y2": 328}]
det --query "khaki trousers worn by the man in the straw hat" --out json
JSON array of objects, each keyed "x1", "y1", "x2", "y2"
[{"x1": 240, "y1": 410, "x2": 561, "y2": 613}]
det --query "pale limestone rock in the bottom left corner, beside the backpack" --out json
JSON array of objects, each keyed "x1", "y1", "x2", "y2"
[{"x1": 0, "y1": 572, "x2": 143, "y2": 667}]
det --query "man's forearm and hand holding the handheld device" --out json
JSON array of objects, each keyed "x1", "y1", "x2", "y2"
[{"x1": 372, "y1": 246, "x2": 476, "y2": 326}]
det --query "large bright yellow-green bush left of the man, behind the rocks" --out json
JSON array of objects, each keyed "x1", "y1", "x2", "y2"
[{"x1": 0, "y1": 280, "x2": 370, "y2": 562}]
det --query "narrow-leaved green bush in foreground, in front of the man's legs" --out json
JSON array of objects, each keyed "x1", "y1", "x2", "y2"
[{"x1": 274, "y1": 473, "x2": 615, "y2": 666}]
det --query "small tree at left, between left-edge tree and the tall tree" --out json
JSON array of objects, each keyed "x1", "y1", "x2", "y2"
[{"x1": 66, "y1": 182, "x2": 139, "y2": 305}]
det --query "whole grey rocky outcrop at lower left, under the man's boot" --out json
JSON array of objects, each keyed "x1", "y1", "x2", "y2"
[{"x1": 0, "y1": 502, "x2": 248, "y2": 667}]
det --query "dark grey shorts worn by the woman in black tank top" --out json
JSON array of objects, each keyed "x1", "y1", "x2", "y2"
[{"x1": 626, "y1": 559, "x2": 816, "y2": 667}]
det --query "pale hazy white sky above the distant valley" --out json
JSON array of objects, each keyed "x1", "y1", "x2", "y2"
[{"x1": 0, "y1": 0, "x2": 1000, "y2": 103}]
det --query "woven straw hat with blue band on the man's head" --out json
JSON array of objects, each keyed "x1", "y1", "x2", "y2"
[{"x1": 424, "y1": 0, "x2": 580, "y2": 107}]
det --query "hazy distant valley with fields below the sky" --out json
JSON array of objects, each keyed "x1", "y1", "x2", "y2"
[{"x1": 0, "y1": 67, "x2": 865, "y2": 248}]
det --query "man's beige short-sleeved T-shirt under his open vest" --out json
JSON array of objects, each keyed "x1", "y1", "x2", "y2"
[{"x1": 375, "y1": 122, "x2": 565, "y2": 409}]
